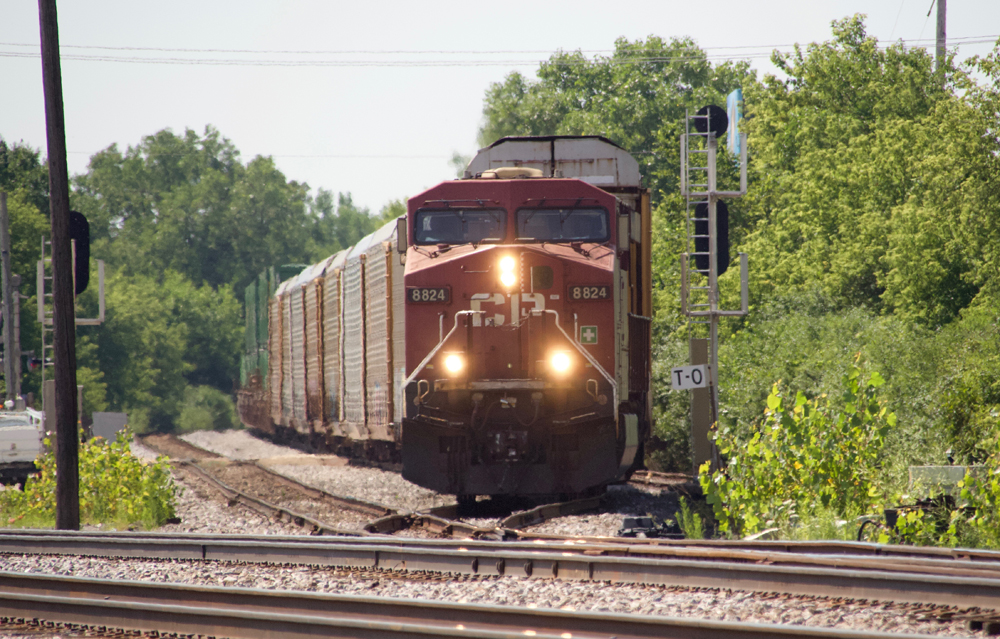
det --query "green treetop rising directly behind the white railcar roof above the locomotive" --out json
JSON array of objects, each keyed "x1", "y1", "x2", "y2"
[{"x1": 479, "y1": 36, "x2": 755, "y2": 198}]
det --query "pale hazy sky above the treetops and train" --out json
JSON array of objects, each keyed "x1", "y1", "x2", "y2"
[{"x1": 0, "y1": 0, "x2": 1000, "y2": 212}]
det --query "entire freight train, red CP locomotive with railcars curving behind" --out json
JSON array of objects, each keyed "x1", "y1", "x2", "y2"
[{"x1": 239, "y1": 136, "x2": 651, "y2": 499}]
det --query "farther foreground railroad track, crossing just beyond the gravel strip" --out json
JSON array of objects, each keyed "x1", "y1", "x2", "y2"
[{"x1": 0, "y1": 530, "x2": 1000, "y2": 619}]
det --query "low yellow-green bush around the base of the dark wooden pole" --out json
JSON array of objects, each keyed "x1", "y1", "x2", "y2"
[{"x1": 0, "y1": 429, "x2": 177, "y2": 529}]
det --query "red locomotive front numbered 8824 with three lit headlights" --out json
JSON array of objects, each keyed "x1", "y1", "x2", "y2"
[{"x1": 401, "y1": 141, "x2": 648, "y2": 496}]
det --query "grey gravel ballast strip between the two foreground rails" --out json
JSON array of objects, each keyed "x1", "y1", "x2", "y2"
[{"x1": 0, "y1": 555, "x2": 980, "y2": 637}]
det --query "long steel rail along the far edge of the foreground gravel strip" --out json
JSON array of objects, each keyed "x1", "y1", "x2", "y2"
[{"x1": 0, "y1": 534, "x2": 1000, "y2": 610}]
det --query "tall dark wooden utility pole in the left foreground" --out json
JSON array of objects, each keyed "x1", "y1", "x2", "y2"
[{"x1": 38, "y1": 0, "x2": 80, "y2": 530}]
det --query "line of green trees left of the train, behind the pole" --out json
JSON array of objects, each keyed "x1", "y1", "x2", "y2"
[{"x1": 0, "y1": 127, "x2": 405, "y2": 432}]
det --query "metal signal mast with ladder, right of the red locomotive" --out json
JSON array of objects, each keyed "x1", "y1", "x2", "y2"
[{"x1": 680, "y1": 106, "x2": 749, "y2": 472}]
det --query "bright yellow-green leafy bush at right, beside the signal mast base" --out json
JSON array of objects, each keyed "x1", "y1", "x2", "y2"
[{"x1": 699, "y1": 367, "x2": 896, "y2": 534}]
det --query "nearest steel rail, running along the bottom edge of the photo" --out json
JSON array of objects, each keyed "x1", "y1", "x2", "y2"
[{"x1": 0, "y1": 573, "x2": 944, "y2": 639}]
